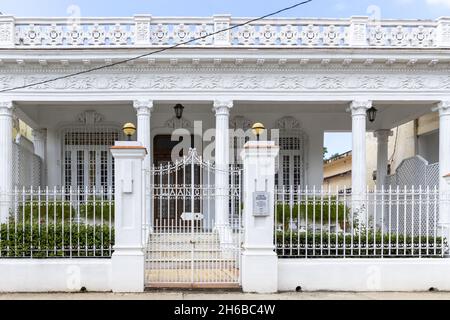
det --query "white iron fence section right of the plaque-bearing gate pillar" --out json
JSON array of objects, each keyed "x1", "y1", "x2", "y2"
[{"x1": 275, "y1": 187, "x2": 448, "y2": 258}]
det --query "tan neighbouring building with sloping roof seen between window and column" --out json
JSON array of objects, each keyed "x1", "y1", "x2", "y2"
[{"x1": 323, "y1": 151, "x2": 352, "y2": 191}]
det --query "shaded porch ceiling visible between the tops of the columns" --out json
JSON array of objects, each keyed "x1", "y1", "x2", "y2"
[{"x1": 16, "y1": 99, "x2": 436, "y2": 131}]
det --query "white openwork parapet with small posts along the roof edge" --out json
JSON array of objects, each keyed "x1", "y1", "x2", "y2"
[{"x1": 0, "y1": 15, "x2": 450, "y2": 48}]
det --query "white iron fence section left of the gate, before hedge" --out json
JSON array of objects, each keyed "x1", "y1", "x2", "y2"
[{"x1": 0, "y1": 188, "x2": 114, "y2": 258}]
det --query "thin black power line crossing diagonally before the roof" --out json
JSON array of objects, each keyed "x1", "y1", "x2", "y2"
[{"x1": 0, "y1": 0, "x2": 313, "y2": 93}]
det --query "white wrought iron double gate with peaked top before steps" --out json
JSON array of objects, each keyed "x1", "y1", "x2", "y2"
[{"x1": 146, "y1": 149, "x2": 243, "y2": 288}]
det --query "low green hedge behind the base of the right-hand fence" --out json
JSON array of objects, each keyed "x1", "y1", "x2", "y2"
[{"x1": 276, "y1": 232, "x2": 448, "y2": 257}]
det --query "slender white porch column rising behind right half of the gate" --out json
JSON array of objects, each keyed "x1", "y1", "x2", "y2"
[{"x1": 214, "y1": 100, "x2": 233, "y2": 230}]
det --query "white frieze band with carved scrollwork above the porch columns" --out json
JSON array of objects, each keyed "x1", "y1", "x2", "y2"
[{"x1": 5, "y1": 74, "x2": 450, "y2": 91}]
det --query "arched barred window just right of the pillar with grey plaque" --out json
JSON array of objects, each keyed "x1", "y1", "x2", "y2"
[{"x1": 275, "y1": 117, "x2": 308, "y2": 189}]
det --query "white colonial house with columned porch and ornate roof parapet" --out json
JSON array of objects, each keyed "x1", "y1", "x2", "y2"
[{"x1": 0, "y1": 15, "x2": 450, "y2": 292}]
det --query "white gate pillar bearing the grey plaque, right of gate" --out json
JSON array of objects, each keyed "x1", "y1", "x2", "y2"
[{"x1": 241, "y1": 141, "x2": 279, "y2": 293}]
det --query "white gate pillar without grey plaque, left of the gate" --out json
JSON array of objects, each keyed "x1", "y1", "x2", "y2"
[{"x1": 111, "y1": 142, "x2": 147, "y2": 292}]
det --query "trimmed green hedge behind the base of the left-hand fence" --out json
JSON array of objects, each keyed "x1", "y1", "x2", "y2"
[{"x1": 0, "y1": 223, "x2": 114, "y2": 258}]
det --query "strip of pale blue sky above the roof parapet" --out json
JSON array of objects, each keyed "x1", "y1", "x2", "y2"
[{"x1": 0, "y1": 0, "x2": 450, "y2": 19}]
